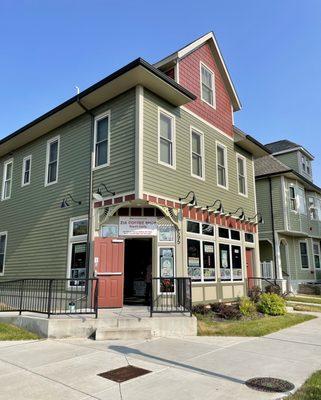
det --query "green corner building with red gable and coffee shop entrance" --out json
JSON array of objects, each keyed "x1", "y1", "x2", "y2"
[{"x1": 0, "y1": 33, "x2": 268, "y2": 307}]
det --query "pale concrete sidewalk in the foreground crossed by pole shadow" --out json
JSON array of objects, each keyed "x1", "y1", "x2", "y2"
[{"x1": 0, "y1": 318, "x2": 321, "y2": 400}]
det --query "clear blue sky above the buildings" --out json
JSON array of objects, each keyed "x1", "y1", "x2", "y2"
[{"x1": 0, "y1": 0, "x2": 321, "y2": 185}]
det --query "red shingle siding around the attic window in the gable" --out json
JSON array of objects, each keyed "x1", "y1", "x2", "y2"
[{"x1": 179, "y1": 44, "x2": 233, "y2": 137}]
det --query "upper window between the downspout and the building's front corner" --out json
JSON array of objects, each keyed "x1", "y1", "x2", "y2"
[{"x1": 95, "y1": 112, "x2": 110, "y2": 167}]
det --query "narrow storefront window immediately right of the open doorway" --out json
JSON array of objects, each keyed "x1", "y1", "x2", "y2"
[{"x1": 159, "y1": 247, "x2": 175, "y2": 293}]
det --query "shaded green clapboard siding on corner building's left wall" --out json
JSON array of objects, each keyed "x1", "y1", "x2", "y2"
[{"x1": 0, "y1": 90, "x2": 135, "y2": 280}]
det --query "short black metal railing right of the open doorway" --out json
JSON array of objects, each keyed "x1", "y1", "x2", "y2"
[{"x1": 150, "y1": 278, "x2": 192, "y2": 317}]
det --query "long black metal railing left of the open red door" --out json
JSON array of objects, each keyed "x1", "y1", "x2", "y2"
[{"x1": 0, "y1": 278, "x2": 98, "y2": 318}]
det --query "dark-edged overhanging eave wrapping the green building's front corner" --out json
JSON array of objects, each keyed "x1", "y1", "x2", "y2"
[{"x1": 0, "y1": 58, "x2": 196, "y2": 157}]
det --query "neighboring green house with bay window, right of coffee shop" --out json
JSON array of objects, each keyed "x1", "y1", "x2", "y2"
[{"x1": 255, "y1": 140, "x2": 321, "y2": 292}]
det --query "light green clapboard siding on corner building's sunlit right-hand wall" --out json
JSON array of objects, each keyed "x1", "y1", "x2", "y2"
[{"x1": 143, "y1": 90, "x2": 255, "y2": 217}]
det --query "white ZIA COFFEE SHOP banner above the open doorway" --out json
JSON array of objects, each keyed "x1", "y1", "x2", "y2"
[{"x1": 119, "y1": 217, "x2": 157, "y2": 236}]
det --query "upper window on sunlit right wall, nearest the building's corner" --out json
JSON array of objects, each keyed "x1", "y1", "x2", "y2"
[{"x1": 158, "y1": 111, "x2": 175, "y2": 167}]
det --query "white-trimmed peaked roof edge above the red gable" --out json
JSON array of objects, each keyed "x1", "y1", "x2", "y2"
[{"x1": 154, "y1": 32, "x2": 242, "y2": 111}]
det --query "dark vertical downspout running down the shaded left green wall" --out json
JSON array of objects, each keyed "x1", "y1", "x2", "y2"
[{"x1": 77, "y1": 96, "x2": 95, "y2": 279}]
